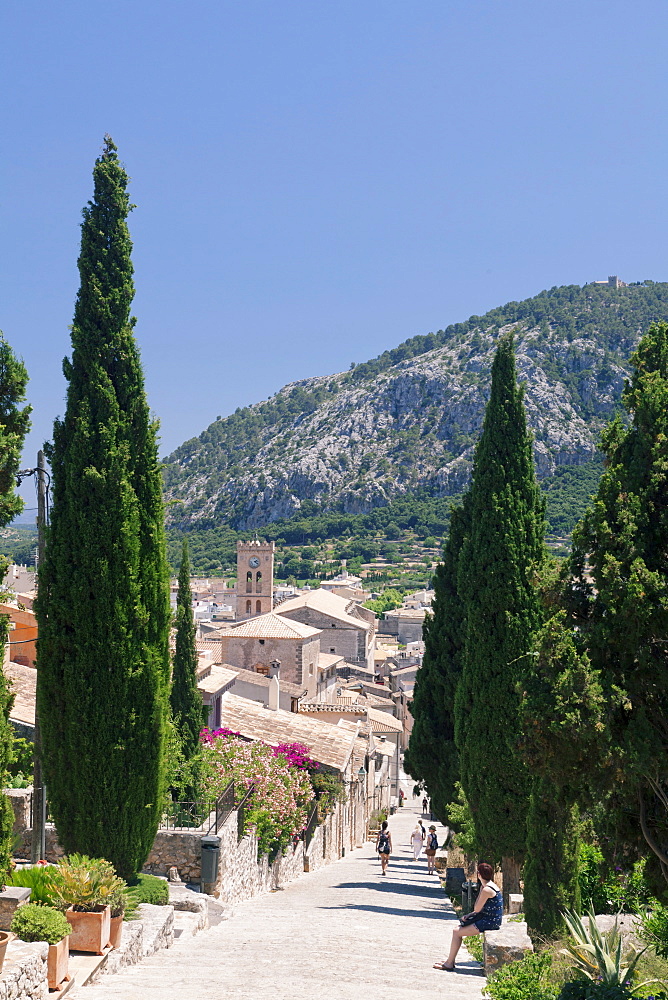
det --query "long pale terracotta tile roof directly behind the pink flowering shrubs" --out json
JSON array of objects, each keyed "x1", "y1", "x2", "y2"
[{"x1": 220, "y1": 692, "x2": 354, "y2": 771}]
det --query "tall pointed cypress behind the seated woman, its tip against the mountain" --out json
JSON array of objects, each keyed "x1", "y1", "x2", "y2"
[{"x1": 455, "y1": 335, "x2": 545, "y2": 893}]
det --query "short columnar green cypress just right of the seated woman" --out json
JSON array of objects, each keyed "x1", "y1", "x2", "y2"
[{"x1": 524, "y1": 778, "x2": 580, "y2": 938}]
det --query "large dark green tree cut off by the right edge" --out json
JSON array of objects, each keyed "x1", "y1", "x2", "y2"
[{"x1": 564, "y1": 323, "x2": 668, "y2": 892}]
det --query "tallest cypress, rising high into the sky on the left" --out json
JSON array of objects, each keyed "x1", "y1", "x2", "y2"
[{"x1": 37, "y1": 137, "x2": 170, "y2": 877}]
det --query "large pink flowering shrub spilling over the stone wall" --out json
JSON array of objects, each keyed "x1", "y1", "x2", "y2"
[{"x1": 201, "y1": 729, "x2": 313, "y2": 856}]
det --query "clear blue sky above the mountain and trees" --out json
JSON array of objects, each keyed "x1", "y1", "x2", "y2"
[{"x1": 0, "y1": 0, "x2": 668, "y2": 512}]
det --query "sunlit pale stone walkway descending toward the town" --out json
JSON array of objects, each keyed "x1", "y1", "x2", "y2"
[{"x1": 76, "y1": 798, "x2": 485, "y2": 1000}]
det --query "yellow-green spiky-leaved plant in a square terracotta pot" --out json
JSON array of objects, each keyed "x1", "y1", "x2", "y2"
[{"x1": 53, "y1": 854, "x2": 125, "y2": 955}]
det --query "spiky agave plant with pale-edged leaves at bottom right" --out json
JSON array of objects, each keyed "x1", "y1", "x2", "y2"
[{"x1": 561, "y1": 906, "x2": 647, "y2": 986}]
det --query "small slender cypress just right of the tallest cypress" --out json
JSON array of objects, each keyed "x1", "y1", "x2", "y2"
[{"x1": 169, "y1": 539, "x2": 204, "y2": 799}]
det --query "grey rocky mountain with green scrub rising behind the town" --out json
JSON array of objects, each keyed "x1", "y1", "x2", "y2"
[{"x1": 165, "y1": 282, "x2": 668, "y2": 530}]
